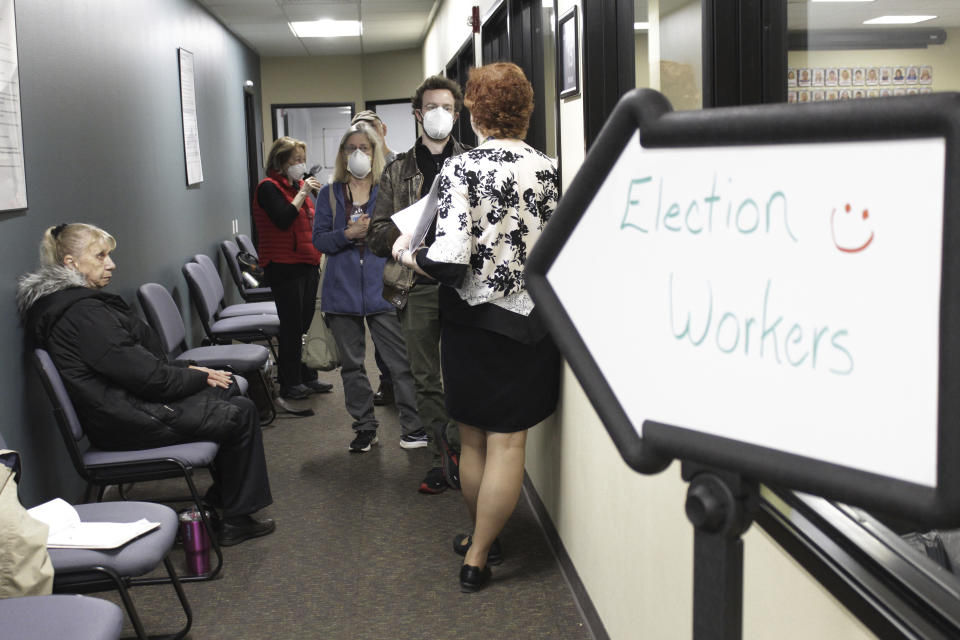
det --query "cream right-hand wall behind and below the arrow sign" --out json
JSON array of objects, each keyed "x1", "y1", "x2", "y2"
[{"x1": 423, "y1": 0, "x2": 873, "y2": 640}]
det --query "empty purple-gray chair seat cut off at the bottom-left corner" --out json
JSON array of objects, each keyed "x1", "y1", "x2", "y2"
[{"x1": 0, "y1": 595, "x2": 123, "y2": 640}]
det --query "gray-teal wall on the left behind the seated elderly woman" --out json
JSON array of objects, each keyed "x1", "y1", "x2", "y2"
[{"x1": 0, "y1": 0, "x2": 262, "y2": 505}]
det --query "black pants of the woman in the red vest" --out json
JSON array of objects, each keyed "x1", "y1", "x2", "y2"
[{"x1": 263, "y1": 262, "x2": 320, "y2": 387}]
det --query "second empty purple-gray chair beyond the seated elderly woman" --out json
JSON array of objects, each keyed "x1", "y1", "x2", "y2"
[{"x1": 183, "y1": 262, "x2": 280, "y2": 359}]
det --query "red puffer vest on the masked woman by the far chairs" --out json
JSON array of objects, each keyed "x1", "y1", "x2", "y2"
[{"x1": 253, "y1": 171, "x2": 322, "y2": 266}]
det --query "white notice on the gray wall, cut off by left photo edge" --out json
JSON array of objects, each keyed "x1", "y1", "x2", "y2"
[{"x1": 0, "y1": 0, "x2": 27, "y2": 211}]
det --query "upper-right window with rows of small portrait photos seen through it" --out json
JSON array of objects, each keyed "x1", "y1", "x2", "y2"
[{"x1": 787, "y1": 0, "x2": 960, "y2": 103}]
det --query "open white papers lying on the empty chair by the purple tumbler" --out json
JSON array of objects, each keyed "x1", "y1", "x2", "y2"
[{"x1": 27, "y1": 498, "x2": 160, "y2": 549}]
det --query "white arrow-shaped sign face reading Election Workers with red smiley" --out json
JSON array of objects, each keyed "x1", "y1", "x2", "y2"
[{"x1": 547, "y1": 133, "x2": 946, "y2": 487}]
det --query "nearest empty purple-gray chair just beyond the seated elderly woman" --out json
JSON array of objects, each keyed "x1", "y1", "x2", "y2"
[{"x1": 137, "y1": 282, "x2": 277, "y2": 426}]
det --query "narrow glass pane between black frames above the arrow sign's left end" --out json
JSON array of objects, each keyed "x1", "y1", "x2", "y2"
[{"x1": 633, "y1": 0, "x2": 703, "y2": 110}]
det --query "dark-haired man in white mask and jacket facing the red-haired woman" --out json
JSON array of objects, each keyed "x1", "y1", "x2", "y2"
[{"x1": 367, "y1": 76, "x2": 469, "y2": 494}]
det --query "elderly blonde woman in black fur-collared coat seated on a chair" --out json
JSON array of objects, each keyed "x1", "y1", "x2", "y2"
[{"x1": 17, "y1": 224, "x2": 275, "y2": 546}]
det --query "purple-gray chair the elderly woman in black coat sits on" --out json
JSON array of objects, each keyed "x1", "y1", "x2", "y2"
[{"x1": 33, "y1": 349, "x2": 223, "y2": 582}]
